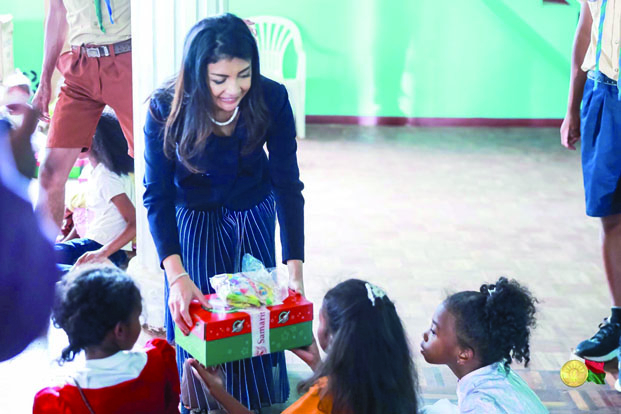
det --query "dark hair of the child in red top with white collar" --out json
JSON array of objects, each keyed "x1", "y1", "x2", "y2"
[{"x1": 52, "y1": 266, "x2": 142, "y2": 363}]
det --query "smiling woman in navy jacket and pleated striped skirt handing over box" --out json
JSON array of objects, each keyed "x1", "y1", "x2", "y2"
[{"x1": 144, "y1": 14, "x2": 304, "y2": 410}]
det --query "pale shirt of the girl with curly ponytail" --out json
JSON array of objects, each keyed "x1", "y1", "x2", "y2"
[{"x1": 457, "y1": 362, "x2": 548, "y2": 414}]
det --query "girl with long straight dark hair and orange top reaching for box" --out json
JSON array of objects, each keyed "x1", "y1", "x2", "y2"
[{"x1": 189, "y1": 279, "x2": 418, "y2": 414}]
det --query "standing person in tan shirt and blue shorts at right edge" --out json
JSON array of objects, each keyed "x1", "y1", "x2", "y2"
[{"x1": 561, "y1": 0, "x2": 621, "y2": 376}]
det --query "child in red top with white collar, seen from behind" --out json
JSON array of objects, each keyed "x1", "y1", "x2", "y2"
[{"x1": 33, "y1": 267, "x2": 180, "y2": 414}]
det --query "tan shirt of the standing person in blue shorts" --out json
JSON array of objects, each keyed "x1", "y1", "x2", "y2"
[{"x1": 581, "y1": 0, "x2": 621, "y2": 80}]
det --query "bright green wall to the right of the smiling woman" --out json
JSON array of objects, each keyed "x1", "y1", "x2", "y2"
[{"x1": 229, "y1": 0, "x2": 579, "y2": 118}]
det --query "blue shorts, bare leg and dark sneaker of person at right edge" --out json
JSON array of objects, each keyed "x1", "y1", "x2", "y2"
[{"x1": 575, "y1": 79, "x2": 621, "y2": 361}]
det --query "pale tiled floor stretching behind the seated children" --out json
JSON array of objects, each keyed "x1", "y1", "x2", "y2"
[{"x1": 0, "y1": 125, "x2": 621, "y2": 414}]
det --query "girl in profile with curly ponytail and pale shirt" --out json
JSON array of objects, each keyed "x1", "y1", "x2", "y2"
[{"x1": 420, "y1": 277, "x2": 548, "y2": 414}]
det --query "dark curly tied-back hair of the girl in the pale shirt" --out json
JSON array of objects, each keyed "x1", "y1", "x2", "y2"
[{"x1": 444, "y1": 277, "x2": 537, "y2": 369}]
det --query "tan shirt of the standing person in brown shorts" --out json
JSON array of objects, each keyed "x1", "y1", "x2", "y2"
[{"x1": 63, "y1": 0, "x2": 131, "y2": 46}]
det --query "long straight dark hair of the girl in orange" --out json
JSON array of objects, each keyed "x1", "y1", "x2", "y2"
[{"x1": 298, "y1": 279, "x2": 418, "y2": 414}]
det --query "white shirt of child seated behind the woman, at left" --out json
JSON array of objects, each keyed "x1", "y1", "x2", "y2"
[{"x1": 84, "y1": 163, "x2": 135, "y2": 250}]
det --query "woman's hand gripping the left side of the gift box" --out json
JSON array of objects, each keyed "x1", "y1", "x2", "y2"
[{"x1": 168, "y1": 275, "x2": 211, "y2": 335}]
